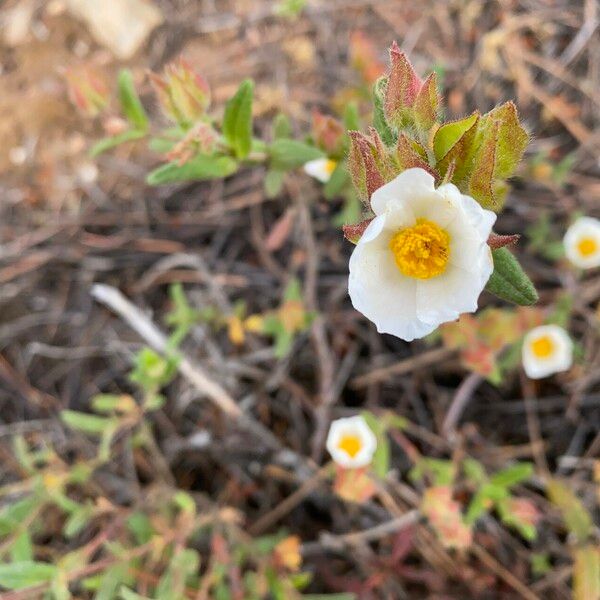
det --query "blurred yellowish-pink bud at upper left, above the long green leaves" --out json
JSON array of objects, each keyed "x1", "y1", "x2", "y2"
[{"x1": 149, "y1": 57, "x2": 210, "y2": 125}]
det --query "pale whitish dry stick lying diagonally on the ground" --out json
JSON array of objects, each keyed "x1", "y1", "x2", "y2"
[{"x1": 90, "y1": 283, "x2": 291, "y2": 453}]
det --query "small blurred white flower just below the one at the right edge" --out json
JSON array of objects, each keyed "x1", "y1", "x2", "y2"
[{"x1": 523, "y1": 325, "x2": 573, "y2": 379}]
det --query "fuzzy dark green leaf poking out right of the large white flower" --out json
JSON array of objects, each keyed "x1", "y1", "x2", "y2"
[{"x1": 485, "y1": 248, "x2": 539, "y2": 306}]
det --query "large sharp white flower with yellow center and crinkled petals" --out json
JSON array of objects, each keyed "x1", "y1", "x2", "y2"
[{"x1": 348, "y1": 169, "x2": 496, "y2": 341}]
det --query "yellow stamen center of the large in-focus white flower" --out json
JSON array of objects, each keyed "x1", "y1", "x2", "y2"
[{"x1": 390, "y1": 219, "x2": 450, "y2": 279}]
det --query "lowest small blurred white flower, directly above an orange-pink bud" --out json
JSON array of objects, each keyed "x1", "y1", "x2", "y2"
[{"x1": 327, "y1": 415, "x2": 377, "y2": 469}]
